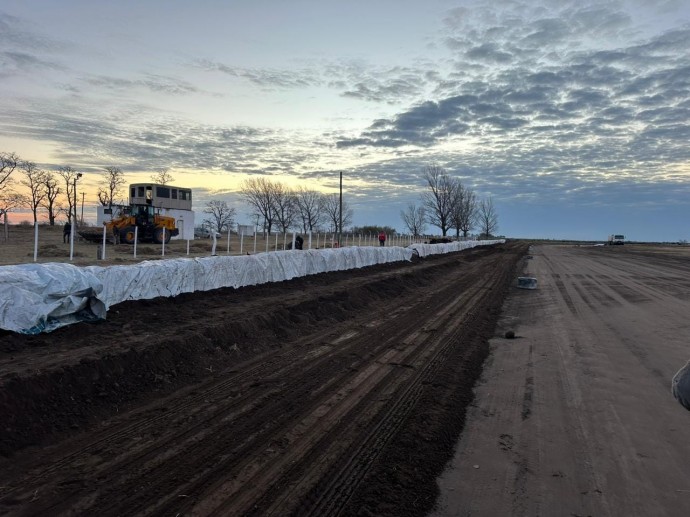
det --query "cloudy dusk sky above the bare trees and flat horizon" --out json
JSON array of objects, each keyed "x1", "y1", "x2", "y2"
[{"x1": 0, "y1": 0, "x2": 690, "y2": 242}]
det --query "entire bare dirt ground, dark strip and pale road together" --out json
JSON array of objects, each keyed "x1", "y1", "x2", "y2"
[{"x1": 0, "y1": 235, "x2": 690, "y2": 516}]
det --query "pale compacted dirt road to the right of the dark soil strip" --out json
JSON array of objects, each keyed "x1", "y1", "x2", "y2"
[{"x1": 434, "y1": 246, "x2": 690, "y2": 516}]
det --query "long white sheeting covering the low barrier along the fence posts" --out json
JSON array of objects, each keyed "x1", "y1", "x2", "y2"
[{"x1": 0, "y1": 241, "x2": 504, "y2": 334}]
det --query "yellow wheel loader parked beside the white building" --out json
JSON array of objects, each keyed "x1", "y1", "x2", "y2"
[{"x1": 105, "y1": 205, "x2": 180, "y2": 244}]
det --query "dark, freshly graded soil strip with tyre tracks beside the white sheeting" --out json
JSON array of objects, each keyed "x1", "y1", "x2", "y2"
[{"x1": 0, "y1": 243, "x2": 525, "y2": 516}]
